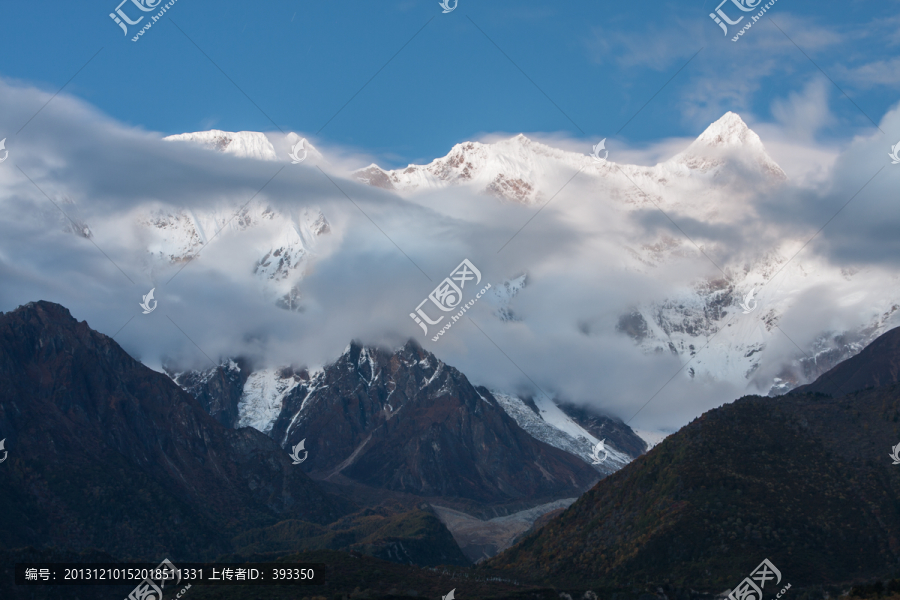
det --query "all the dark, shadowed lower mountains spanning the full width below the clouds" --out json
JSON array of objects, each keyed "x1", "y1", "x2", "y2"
[{"x1": 0, "y1": 302, "x2": 900, "y2": 599}]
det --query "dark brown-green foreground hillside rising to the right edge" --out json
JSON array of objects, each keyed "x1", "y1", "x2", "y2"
[{"x1": 487, "y1": 330, "x2": 900, "y2": 592}]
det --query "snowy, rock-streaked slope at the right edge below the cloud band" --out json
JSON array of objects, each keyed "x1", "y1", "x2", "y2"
[{"x1": 617, "y1": 252, "x2": 900, "y2": 395}]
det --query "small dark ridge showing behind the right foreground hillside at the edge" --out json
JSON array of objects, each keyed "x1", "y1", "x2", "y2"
[{"x1": 791, "y1": 327, "x2": 900, "y2": 396}]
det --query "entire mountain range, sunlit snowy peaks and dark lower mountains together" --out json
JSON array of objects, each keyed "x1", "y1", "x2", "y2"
[{"x1": 7, "y1": 113, "x2": 900, "y2": 600}]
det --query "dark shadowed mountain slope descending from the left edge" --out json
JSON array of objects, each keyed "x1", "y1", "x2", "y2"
[{"x1": 0, "y1": 302, "x2": 352, "y2": 560}]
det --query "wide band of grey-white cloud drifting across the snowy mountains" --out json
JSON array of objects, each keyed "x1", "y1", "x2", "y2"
[{"x1": 0, "y1": 84, "x2": 900, "y2": 436}]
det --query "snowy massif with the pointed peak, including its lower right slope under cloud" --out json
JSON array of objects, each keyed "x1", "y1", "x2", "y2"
[{"x1": 354, "y1": 112, "x2": 900, "y2": 394}]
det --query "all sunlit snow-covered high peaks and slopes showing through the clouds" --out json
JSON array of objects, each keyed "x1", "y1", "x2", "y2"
[{"x1": 153, "y1": 112, "x2": 900, "y2": 406}]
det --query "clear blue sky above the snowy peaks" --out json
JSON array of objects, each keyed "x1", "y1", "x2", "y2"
[{"x1": 0, "y1": 0, "x2": 900, "y2": 167}]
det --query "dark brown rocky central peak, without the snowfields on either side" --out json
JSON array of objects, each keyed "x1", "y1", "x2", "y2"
[{"x1": 272, "y1": 342, "x2": 599, "y2": 504}]
